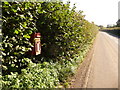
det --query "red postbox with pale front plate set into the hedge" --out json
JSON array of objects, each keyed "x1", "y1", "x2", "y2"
[{"x1": 30, "y1": 33, "x2": 41, "y2": 55}]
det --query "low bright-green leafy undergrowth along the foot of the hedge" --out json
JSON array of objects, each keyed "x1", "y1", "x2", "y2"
[{"x1": 1, "y1": 52, "x2": 85, "y2": 89}]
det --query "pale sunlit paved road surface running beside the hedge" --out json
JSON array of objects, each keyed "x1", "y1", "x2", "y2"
[{"x1": 87, "y1": 31, "x2": 119, "y2": 88}]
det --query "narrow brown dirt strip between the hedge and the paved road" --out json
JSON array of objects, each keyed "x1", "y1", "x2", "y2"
[{"x1": 69, "y1": 32, "x2": 99, "y2": 88}]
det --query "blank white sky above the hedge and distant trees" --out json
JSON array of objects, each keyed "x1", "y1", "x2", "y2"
[{"x1": 63, "y1": 0, "x2": 120, "y2": 26}]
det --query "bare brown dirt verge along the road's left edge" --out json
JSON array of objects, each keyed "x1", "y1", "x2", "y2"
[{"x1": 70, "y1": 36, "x2": 95, "y2": 88}]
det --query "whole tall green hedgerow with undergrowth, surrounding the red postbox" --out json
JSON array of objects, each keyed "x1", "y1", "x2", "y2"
[{"x1": 2, "y1": 2, "x2": 98, "y2": 88}]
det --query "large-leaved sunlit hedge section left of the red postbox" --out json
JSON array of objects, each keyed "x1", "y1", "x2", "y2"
[{"x1": 2, "y1": 2, "x2": 37, "y2": 74}]
